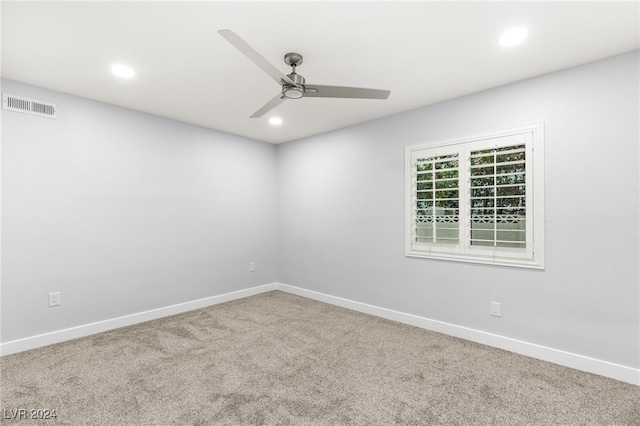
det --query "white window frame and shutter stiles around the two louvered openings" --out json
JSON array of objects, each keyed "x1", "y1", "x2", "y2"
[{"x1": 405, "y1": 123, "x2": 545, "y2": 269}]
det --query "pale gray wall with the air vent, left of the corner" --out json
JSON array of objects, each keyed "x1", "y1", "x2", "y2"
[{"x1": 2, "y1": 81, "x2": 277, "y2": 342}]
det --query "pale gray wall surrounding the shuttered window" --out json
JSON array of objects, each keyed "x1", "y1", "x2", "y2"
[{"x1": 278, "y1": 52, "x2": 640, "y2": 368}]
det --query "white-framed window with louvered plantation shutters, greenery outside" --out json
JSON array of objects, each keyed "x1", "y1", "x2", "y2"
[{"x1": 406, "y1": 124, "x2": 544, "y2": 269}]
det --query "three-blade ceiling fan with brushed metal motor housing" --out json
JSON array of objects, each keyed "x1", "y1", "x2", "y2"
[{"x1": 218, "y1": 30, "x2": 391, "y2": 118}]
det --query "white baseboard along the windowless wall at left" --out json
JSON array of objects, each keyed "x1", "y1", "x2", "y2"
[{"x1": 0, "y1": 283, "x2": 277, "y2": 355}]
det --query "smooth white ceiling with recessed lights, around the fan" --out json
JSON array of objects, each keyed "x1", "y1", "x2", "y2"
[{"x1": 1, "y1": 1, "x2": 640, "y2": 143}]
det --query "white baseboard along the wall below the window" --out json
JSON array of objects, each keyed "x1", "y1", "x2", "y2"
[{"x1": 276, "y1": 283, "x2": 640, "y2": 386}]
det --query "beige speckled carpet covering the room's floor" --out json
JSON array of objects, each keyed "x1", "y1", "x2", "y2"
[{"x1": 0, "y1": 292, "x2": 640, "y2": 426}]
